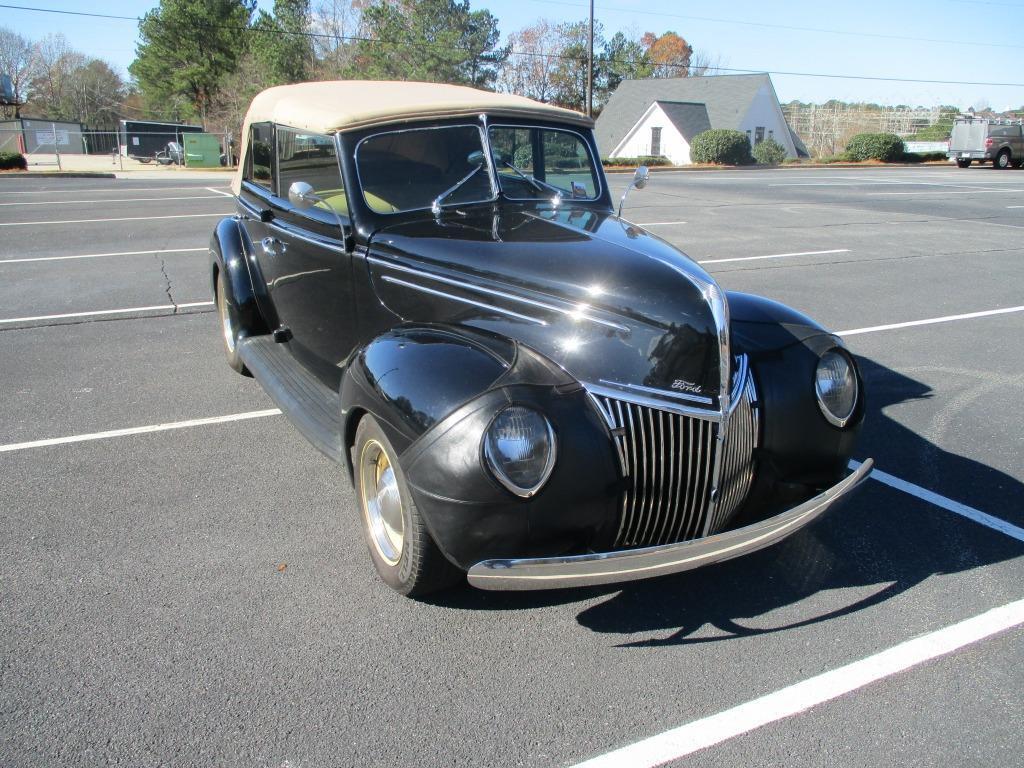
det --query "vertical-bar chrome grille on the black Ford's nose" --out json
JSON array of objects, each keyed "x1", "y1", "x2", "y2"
[{"x1": 594, "y1": 366, "x2": 759, "y2": 547}]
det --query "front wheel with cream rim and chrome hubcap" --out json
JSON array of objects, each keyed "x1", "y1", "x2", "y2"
[{"x1": 352, "y1": 416, "x2": 460, "y2": 597}]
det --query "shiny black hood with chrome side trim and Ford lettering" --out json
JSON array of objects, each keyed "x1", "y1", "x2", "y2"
[{"x1": 368, "y1": 207, "x2": 729, "y2": 408}]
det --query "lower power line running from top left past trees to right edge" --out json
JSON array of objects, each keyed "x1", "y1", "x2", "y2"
[{"x1": 6, "y1": 0, "x2": 1024, "y2": 88}]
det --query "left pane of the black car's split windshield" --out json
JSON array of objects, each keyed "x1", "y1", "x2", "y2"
[{"x1": 355, "y1": 125, "x2": 495, "y2": 213}]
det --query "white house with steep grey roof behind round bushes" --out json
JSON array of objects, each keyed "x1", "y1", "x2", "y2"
[{"x1": 594, "y1": 75, "x2": 808, "y2": 165}]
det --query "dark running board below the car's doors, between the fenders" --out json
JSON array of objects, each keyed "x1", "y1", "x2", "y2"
[{"x1": 239, "y1": 336, "x2": 345, "y2": 463}]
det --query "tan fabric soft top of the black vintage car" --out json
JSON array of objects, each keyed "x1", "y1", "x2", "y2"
[{"x1": 231, "y1": 80, "x2": 594, "y2": 195}]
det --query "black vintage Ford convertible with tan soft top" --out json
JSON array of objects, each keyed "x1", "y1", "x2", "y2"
[{"x1": 210, "y1": 82, "x2": 871, "y2": 595}]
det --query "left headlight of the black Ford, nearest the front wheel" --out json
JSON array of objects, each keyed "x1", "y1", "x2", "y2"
[{"x1": 483, "y1": 406, "x2": 555, "y2": 498}]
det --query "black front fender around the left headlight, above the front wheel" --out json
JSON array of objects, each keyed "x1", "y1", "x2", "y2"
[{"x1": 341, "y1": 326, "x2": 621, "y2": 567}]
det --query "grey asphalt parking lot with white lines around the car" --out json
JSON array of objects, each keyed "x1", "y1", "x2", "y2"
[{"x1": 0, "y1": 166, "x2": 1024, "y2": 768}]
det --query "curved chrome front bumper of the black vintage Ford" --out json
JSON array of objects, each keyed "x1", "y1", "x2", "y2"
[{"x1": 468, "y1": 459, "x2": 873, "y2": 590}]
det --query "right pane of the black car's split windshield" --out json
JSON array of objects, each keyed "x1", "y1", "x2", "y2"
[{"x1": 489, "y1": 125, "x2": 598, "y2": 200}]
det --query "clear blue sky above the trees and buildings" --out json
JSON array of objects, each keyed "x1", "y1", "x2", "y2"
[{"x1": 6, "y1": 0, "x2": 1024, "y2": 110}]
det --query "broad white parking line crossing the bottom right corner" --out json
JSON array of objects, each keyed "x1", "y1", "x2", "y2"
[{"x1": 575, "y1": 600, "x2": 1024, "y2": 768}]
